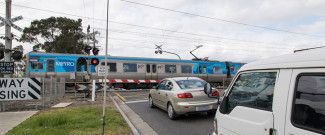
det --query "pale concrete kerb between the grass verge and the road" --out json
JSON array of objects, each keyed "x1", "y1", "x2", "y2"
[{"x1": 113, "y1": 95, "x2": 158, "y2": 135}]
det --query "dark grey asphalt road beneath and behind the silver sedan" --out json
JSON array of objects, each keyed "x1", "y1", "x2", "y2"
[{"x1": 126, "y1": 102, "x2": 214, "y2": 135}]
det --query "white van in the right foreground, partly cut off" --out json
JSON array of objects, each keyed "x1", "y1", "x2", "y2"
[{"x1": 208, "y1": 49, "x2": 325, "y2": 135}]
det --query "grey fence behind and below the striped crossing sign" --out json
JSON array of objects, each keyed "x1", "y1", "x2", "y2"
[{"x1": 0, "y1": 76, "x2": 65, "y2": 111}]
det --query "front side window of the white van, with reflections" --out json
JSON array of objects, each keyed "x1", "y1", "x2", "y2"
[{"x1": 220, "y1": 72, "x2": 277, "y2": 113}]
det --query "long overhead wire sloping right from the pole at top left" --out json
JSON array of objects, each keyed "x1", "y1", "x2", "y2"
[{"x1": 0, "y1": 2, "x2": 314, "y2": 45}]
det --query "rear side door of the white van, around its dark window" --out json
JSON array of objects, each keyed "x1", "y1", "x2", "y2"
[{"x1": 285, "y1": 68, "x2": 325, "y2": 135}]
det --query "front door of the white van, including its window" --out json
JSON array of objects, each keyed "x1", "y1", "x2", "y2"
[{"x1": 216, "y1": 70, "x2": 278, "y2": 135}]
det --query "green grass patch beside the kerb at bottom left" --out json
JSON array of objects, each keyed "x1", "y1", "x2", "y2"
[{"x1": 6, "y1": 107, "x2": 131, "y2": 135}]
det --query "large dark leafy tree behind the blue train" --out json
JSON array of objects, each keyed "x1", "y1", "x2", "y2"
[{"x1": 20, "y1": 17, "x2": 85, "y2": 54}]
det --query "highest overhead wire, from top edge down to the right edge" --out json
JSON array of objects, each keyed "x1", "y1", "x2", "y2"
[{"x1": 120, "y1": 0, "x2": 325, "y2": 38}]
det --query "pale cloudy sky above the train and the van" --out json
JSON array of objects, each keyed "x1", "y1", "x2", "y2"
[{"x1": 0, "y1": 0, "x2": 325, "y2": 62}]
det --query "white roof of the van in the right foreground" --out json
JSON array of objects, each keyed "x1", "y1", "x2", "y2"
[{"x1": 240, "y1": 48, "x2": 325, "y2": 71}]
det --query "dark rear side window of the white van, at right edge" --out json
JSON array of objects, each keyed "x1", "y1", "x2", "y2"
[{"x1": 291, "y1": 74, "x2": 325, "y2": 134}]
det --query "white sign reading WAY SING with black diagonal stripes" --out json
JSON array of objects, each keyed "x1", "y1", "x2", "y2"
[{"x1": 0, "y1": 78, "x2": 42, "y2": 101}]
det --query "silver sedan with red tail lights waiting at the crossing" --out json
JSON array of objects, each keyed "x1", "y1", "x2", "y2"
[{"x1": 149, "y1": 77, "x2": 219, "y2": 119}]
